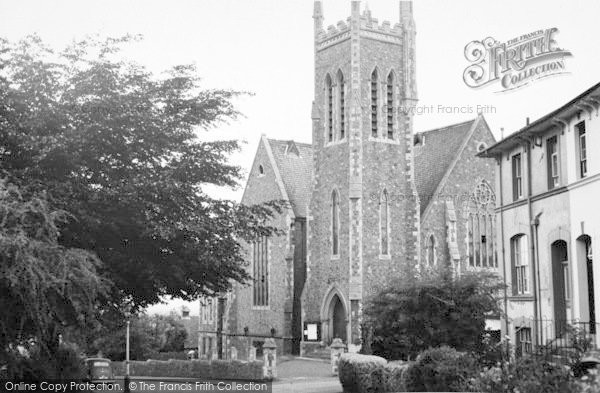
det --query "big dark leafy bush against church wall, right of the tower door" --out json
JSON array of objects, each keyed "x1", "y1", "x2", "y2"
[{"x1": 364, "y1": 273, "x2": 502, "y2": 360}]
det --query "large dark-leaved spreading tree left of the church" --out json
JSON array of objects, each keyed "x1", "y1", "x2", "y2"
[{"x1": 0, "y1": 36, "x2": 281, "y2": 318}]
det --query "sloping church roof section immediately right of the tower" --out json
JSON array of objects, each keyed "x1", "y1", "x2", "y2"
[{"x1": 413, "y1": 119, "x2": 477, "y2": 214}]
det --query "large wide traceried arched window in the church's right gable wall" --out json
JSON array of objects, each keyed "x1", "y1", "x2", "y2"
[{"x1": 467, "y1": 181, "x2": 498, "y2": 267}]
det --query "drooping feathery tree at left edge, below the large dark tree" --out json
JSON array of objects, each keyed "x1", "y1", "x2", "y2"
[{"x1": 0, "y1": 180, "x2": 109, "y2": 372}]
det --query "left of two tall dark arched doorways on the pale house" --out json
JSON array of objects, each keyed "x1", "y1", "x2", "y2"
[{"x1": 551, "y1": 240, "x2": 571, "y2": 337}]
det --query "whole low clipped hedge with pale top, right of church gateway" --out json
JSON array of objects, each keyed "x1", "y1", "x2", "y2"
[{"x1": 338, "y1": 353, "x2": 407, "y2": 393}]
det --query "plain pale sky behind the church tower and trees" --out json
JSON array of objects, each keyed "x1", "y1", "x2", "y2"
[{"x1": 0, "y1": 0, "x2": 600, "y2": 314}]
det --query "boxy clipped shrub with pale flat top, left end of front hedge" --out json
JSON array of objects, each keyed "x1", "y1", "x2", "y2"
[{"x1": 338, "y1": 353, "x2": 387, "y2": 393}]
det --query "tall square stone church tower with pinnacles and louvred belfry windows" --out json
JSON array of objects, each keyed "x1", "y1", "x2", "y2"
[{"x1": 303, "y1": 1, "x2": 419, "y2": 351}]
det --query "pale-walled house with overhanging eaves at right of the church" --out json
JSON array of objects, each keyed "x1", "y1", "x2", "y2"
[{"x1": 480, "y1": 84, "x2": 600, "y2": 352}]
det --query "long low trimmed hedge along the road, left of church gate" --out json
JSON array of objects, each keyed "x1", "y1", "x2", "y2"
[{"x1": 112, "y1": 359, "x2": 264, "y2": 381}]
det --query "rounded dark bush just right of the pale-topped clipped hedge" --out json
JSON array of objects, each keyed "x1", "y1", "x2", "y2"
[{"x1": 403, "y1": 346, "x2": 478, "y2": 392}]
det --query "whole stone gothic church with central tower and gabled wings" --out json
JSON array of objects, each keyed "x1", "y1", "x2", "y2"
[{"x1": 206, "y1": 1, "x2": 499, "y2": 358}]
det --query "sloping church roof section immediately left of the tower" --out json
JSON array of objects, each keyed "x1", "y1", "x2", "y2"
[{"x1": 267, "y1": 139, "x2": 313, "y2": 217}]
